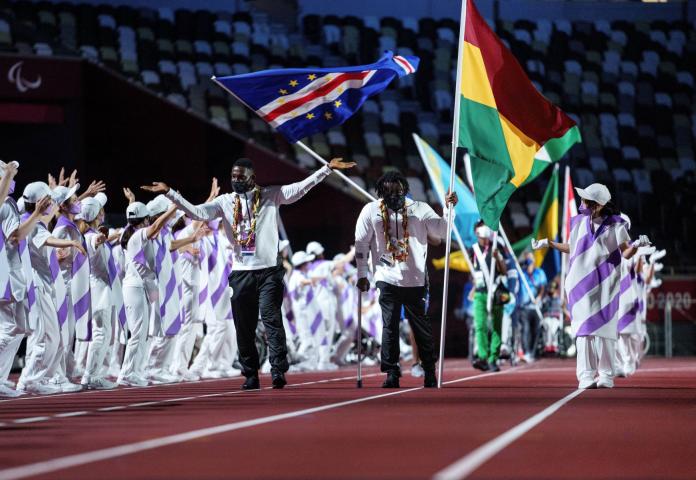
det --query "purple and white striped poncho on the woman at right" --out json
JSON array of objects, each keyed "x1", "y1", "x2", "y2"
[{"x1": 565, "y1": 215, "x2": 630, "y2": 339}]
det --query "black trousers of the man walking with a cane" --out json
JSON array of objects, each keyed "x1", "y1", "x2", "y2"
[{"x1": 377, "y1": 282, "x2": 437, "y2": 375}]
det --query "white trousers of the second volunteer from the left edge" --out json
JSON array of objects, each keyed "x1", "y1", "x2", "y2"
[{"x1": 18, "y1": 286, "x2": 63, "y2": 386}]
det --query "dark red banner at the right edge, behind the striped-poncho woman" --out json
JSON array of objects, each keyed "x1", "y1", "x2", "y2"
[{"x1": 648, "y1": 276, "x2": 696, "y2": 322}]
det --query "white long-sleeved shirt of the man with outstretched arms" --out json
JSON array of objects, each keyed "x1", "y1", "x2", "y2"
[{"x1": 167, "y1": 167, "x2": 331, "y2": 271}]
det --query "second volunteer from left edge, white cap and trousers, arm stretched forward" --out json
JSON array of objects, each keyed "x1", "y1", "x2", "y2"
[{"x1": 17, "y1": 182, "x2": 87, "y2": 395}]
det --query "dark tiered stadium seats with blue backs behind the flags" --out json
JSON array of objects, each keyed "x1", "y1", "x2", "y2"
[{"x1": 0, "y1": 1, "x2": 696, "y2": 260}]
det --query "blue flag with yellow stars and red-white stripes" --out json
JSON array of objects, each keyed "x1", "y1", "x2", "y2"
[{"x1": 213, "y1": 52, "x2": 419, "y2": 143}]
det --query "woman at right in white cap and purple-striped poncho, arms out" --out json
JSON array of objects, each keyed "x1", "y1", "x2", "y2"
[{"x1": 532, "y1": 183, "x2": 650, "y2": 389}]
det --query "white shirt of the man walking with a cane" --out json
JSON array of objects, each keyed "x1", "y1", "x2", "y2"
[{"x1": 355, "y1": 199, "x2": 447, "y2": 287}]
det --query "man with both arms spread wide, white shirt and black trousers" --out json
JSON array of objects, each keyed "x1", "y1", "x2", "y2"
[{"x1": 149, "y1": 159, "x2": 354, "y2": 390}]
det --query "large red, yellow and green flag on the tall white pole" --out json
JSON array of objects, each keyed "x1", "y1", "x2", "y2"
[{"x1": 457, "y1": 0, "x2": 581, "y2": 230}]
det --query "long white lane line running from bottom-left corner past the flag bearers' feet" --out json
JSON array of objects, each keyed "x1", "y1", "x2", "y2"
[{"x1": 0, "y1": 367, "x2": 521, "y2": 480}]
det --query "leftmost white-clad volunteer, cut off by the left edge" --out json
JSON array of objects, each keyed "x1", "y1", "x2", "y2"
[{"x1": 0, "y1": 161, "x2": 32, "y2": 397}]
